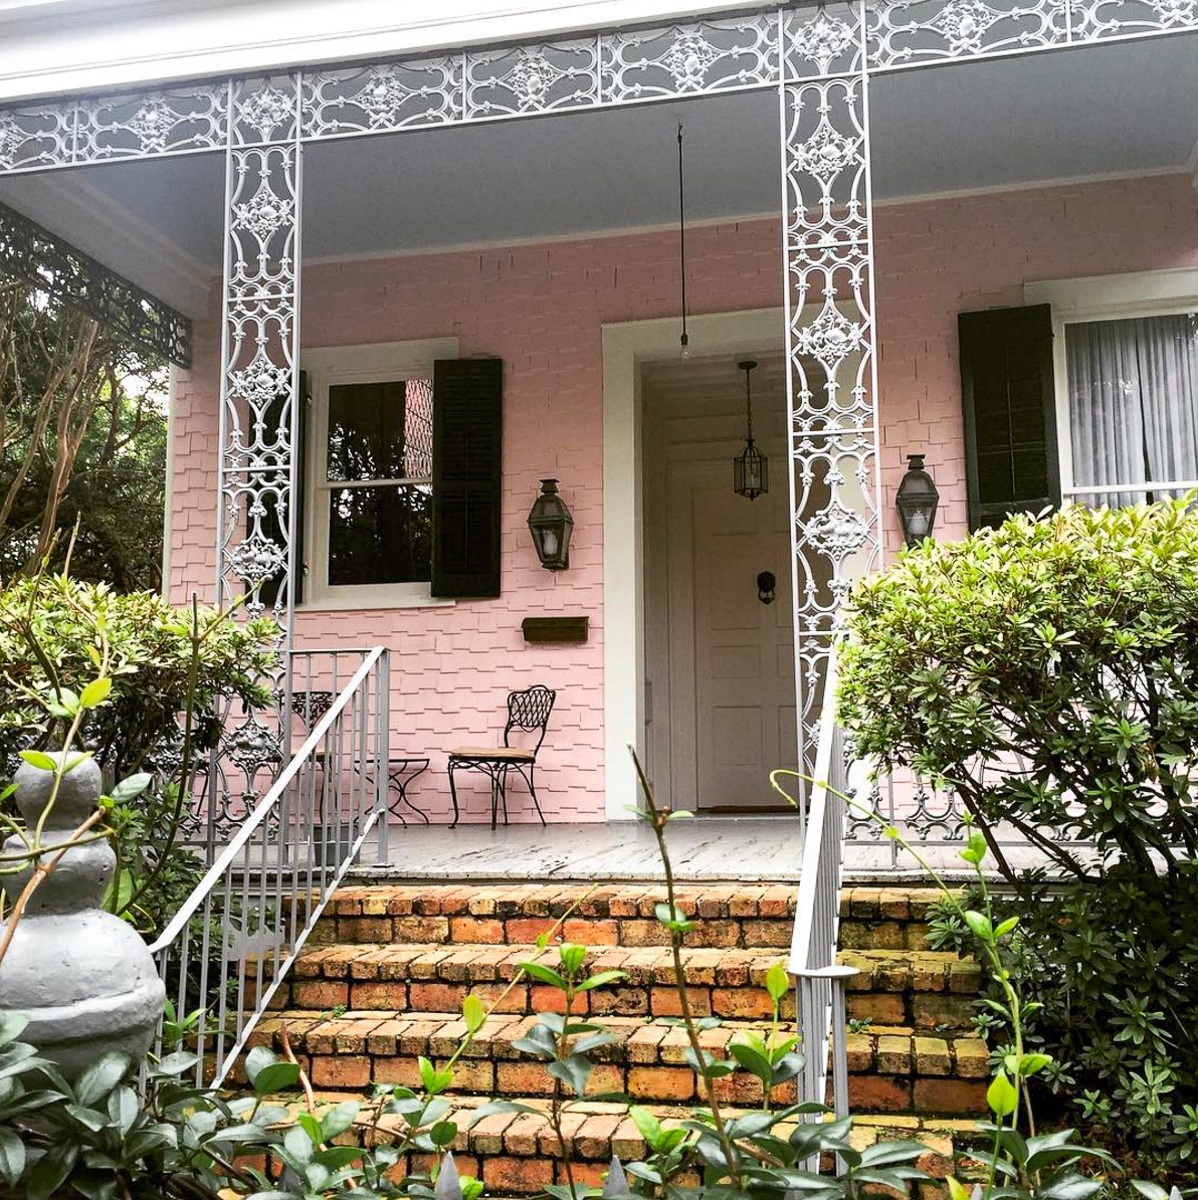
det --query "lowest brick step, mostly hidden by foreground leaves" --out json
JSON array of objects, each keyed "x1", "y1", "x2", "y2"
[{"x1": 285, "y1": 1092, "x2": 977, "y2": 1200}]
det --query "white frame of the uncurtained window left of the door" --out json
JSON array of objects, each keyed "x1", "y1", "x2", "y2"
[{"x1": 300, "y1": 337, "x2": 457, "y2": 611}]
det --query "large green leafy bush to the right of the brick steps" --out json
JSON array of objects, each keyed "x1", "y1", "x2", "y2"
[{"x1": 839, "y1": 500, "x2": 1198, "y2": 1171}]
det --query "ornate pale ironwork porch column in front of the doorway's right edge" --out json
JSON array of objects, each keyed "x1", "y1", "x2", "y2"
[{"x1": 779, "y1": 0, "x2": 881, "y2": 775}]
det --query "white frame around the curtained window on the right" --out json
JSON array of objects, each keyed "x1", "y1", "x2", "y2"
[{"x1": 1023, "y1": 266, "x2": 1198, "y2": 502}]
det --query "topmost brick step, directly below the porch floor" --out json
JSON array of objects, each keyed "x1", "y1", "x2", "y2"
[{"x1": 313, "y1": 883, "x2": 939, "y2": 949}]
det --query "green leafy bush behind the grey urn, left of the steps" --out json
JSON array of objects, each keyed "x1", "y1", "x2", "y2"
[{"x1": 0, "y1": 575, "x2": 277, "y2": 932}]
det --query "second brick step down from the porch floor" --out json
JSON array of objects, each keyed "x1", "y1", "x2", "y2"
[{"x1": 285, "y1": 943, "x2": 981, "y2": 1030}]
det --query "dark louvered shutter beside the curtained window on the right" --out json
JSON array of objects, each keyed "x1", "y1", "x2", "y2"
[{"x1": 957, "y1": 305, "x2": 1061, "y2": 529}]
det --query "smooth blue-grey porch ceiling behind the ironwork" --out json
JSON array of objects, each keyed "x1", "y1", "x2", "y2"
[{"x1": 0, "y1": 35, "x2": 1198, "y2": 312}]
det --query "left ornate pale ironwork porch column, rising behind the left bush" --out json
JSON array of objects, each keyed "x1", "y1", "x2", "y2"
[{"x1": 209, "y1": 74, "x2": 303, "y2": 823}]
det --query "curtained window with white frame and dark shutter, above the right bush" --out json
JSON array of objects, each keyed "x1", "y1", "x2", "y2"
[{"x1": 959, "y1": 270, "x2": 1198, "y2": 528}]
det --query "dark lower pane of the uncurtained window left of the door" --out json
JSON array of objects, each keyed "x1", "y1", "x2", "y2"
[{"x1": 329, "y1": 485, "x2": 432, "y2": 587}]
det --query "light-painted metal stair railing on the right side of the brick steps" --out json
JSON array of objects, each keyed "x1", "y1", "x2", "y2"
[{"x1": 787, "y1": 656, "x2": 857, "y2": 1142}]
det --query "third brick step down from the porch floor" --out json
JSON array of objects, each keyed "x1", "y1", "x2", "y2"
[{"x1": 254, "y1": 1010, "x2": 988, "y2": 1116}]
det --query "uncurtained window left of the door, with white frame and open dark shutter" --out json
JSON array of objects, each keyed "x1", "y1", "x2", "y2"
[{"x1": 301, "y1": 338, "x2": 502, "y2": 608}]
